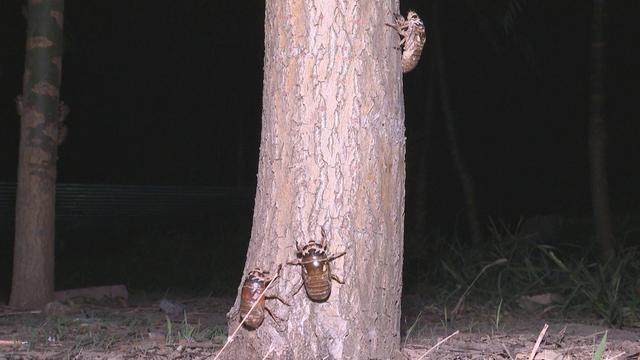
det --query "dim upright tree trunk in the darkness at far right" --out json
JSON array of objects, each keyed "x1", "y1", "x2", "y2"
[{"x1": 589, "y1": 0, "x2": 615, "y2": 257}]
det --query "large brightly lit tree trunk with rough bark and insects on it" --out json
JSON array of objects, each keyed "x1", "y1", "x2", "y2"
[{"x1": 226, "y1": 0, "x2": 405, "y2": 359}]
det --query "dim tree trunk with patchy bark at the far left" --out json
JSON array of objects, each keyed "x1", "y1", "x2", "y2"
[{"x1": 10, "y1": 0, "x2": 64, "y2": 308}]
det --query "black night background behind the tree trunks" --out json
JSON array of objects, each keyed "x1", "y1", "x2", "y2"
[{"x1": 0, "y1": 0, "x2": 640, "y2": 298}]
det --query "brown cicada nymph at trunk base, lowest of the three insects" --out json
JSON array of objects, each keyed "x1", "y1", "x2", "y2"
[{"x1": 240, "y1": 265, "x2": 289, "y2": 329}]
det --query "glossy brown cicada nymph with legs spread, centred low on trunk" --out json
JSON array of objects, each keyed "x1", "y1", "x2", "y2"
[{"x1": 287, "y1": 229, "x2": 346, "y2": 302}]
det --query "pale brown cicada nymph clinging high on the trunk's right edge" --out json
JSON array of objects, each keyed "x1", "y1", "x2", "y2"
[{"x1": 386, "y1": 10, "x2": 427, "y2": 73}]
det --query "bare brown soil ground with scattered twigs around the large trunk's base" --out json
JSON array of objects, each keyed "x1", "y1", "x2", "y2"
[{"x1": 0, "y1": 297, "x2": 640, "y2": 360}]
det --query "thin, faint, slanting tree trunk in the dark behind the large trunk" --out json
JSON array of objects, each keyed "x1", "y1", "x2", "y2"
[{"x1": 432, "y1": 1, "x2": 482, "y2": 244}]
